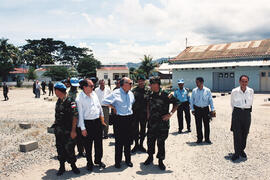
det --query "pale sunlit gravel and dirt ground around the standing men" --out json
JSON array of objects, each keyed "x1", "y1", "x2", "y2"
[{"x1": 0, "y1": 88, "x2": 270, "y2": 180}]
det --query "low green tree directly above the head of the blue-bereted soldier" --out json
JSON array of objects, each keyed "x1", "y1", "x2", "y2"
[{"x1": 43, "y1": 67, "x2": 70, "y2": 81}]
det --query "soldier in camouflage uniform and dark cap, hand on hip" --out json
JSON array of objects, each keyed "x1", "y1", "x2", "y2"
[{"x1": 144, "y1": 77, "x2": 180, "y2": 170}]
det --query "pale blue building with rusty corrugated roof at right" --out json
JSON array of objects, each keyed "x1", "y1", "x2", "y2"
[{"x1": 160, "y1": 39, "x2": 270, "y2": 91}]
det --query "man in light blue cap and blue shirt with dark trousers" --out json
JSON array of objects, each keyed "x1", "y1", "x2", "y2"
[{"x1": 174, "y1": 79, "x2": 191, "y2": 134}]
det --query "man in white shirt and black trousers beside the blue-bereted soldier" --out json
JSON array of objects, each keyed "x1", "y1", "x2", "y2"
[{"x1": 76, "y1": 79, "x2": 106, "y2": 171}]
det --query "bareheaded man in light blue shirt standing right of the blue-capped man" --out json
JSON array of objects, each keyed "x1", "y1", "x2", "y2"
[{"x1": 190, "y1": 77, "x2": 215, "y2": 144}]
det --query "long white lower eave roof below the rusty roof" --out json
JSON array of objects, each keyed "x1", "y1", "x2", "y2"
[{"x1": 159, "y1": 60, "x2": 270, "y2": 71}]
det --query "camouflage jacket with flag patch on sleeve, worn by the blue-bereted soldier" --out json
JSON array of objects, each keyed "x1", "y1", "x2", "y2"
[{"x1": 55, "y1": 97, "x2": 78, "y2": 131}]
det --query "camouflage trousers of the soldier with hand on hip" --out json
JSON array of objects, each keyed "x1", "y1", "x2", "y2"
[{"x1": 147, "y1": 125, "x2": 169, "y2": 160}]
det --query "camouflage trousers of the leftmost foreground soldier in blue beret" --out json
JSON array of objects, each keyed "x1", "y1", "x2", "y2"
[{"x1": 54, "y1": 127, "x2": 76, "y2": 164}]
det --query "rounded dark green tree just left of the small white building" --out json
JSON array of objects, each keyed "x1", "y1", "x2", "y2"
[{"x1": 77, "y1": 54, "x2": 101, "y2": 77}]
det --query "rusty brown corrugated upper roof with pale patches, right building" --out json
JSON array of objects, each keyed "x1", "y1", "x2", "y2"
[{"x1": 170, "y1": 39, "x2": 270, "y2": 63}]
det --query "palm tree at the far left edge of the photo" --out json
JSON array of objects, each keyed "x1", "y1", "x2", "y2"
[{"x1": 0, "y1": 38, "x2": 21, "y2": 80}]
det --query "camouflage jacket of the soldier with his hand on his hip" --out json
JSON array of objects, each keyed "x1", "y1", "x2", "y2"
[{"x1": 148, "y1": 89, "x2": 181, "y2": 129}]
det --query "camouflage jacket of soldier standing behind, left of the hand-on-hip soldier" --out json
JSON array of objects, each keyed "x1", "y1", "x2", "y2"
[{"x1": 132, "y1": 86, "x2": 151, "y2": 113}]
